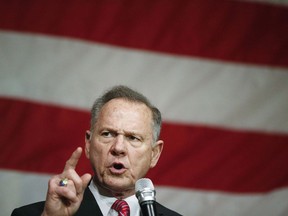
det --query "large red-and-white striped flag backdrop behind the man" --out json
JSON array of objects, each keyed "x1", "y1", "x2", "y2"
[{"x1": 0, "y1": 0, "x2": 288, "y2": 216}]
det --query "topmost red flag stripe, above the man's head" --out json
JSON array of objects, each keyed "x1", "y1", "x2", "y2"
[{"x1": 0, "y1": 0, "x2": 288, "y2": 67}]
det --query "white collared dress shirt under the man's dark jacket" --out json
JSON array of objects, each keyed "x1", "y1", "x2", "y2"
[{"x1": 88, "y1": 181, "x2": 140, "y2": 216}]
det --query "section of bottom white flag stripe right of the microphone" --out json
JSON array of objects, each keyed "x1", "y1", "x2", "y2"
[{"x1": 156, "y1": 186, "x2": 288, "y2": 216}]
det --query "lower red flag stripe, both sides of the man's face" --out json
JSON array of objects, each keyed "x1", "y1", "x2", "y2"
[{"x1": 0, "y1": 98, "x2": 288, "y2": 192}]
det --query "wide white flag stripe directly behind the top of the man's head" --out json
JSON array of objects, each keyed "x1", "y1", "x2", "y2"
[{"x1": 0, "y1": 32, "x2": 288, "y2": 133}]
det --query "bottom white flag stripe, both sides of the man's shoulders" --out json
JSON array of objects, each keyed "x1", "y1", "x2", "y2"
[{"x1": 0, "y1": 170, "x2": 288, "y2": 216}]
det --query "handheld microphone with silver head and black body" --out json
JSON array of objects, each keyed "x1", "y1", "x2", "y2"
[{"x1": 135, "y1": 178, "x2": 157, "y2": 216}]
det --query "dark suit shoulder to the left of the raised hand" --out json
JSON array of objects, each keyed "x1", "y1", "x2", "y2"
[{"x1": 11, "y1": 202, "x2": 45, "y2": 216}]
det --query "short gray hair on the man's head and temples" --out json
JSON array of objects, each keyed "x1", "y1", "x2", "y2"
[{"x1": 90, "y1": 85, "x2": 162, "y2": 142}]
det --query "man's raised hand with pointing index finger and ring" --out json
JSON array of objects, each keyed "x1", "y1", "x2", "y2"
[{"x1": 42, "y1": 147, "x2": 91, "y2": 216}]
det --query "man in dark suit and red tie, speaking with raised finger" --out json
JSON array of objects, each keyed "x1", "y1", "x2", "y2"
[{"x1": 12, "y1": 86, "x2": 179, "y2": 216}]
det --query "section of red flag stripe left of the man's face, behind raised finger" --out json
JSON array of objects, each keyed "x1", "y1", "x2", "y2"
[{"x1": 0, "y1": 98, "x2": 89, "y2": 176}]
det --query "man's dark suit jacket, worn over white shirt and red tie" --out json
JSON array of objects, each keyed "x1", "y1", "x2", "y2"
[{"x1": 11, "y1": 188, "x2": 181, "y2": 216}]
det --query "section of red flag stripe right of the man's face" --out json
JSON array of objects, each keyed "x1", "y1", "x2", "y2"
[{"x1": 151, "y1": 123, "x2": 288, "y2": 192}]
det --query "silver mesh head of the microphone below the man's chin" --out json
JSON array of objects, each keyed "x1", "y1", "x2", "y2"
[{"x1": 135, "y1": 178, "x2": 156, "y2": 204}]
